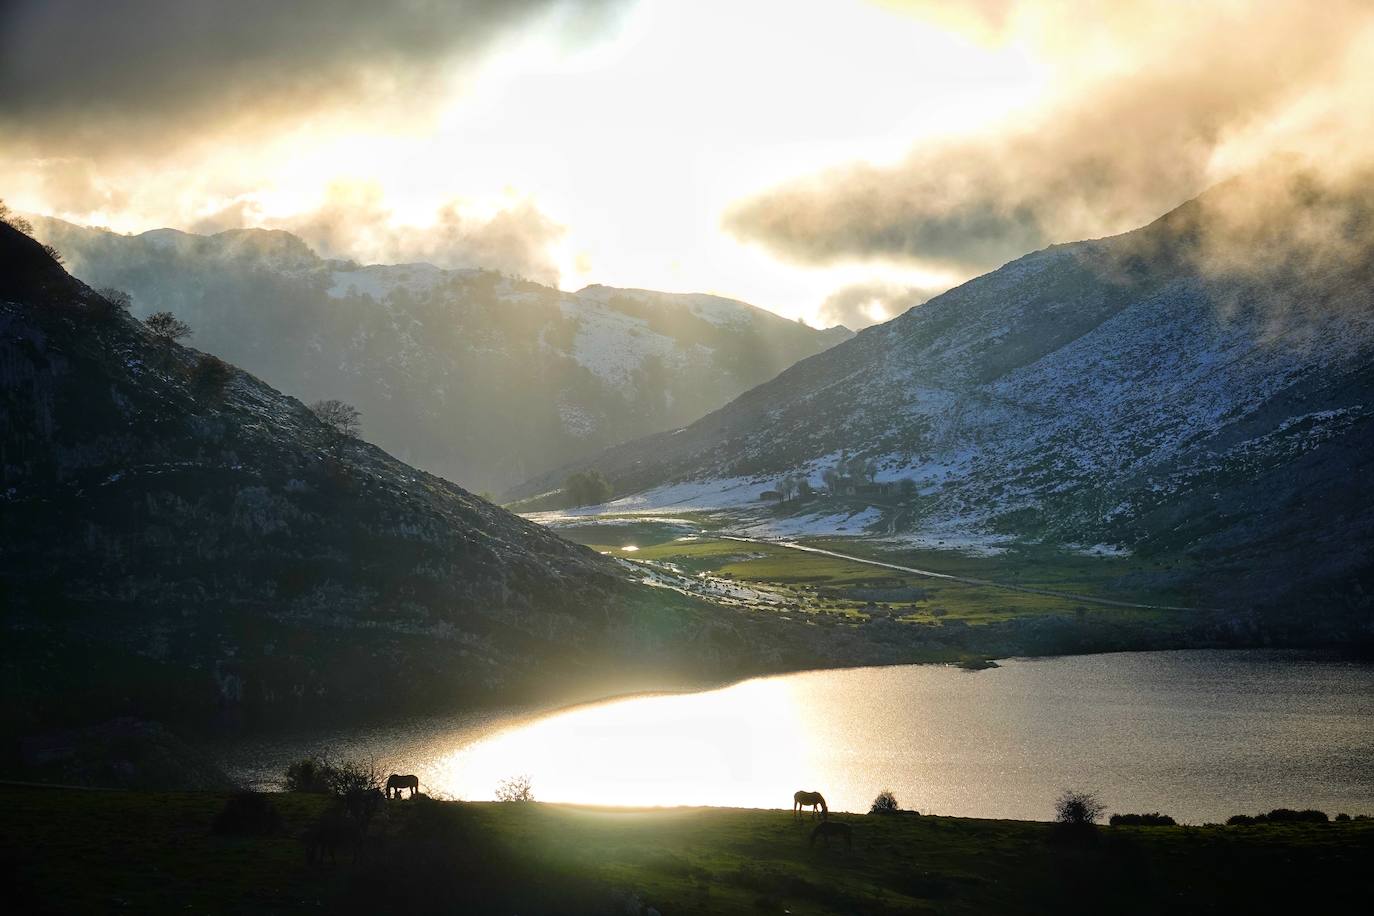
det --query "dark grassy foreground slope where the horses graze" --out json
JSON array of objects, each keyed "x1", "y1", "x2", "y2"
[{"x1": 0, "y1": 787, "x2": 1374, "y2": 915}]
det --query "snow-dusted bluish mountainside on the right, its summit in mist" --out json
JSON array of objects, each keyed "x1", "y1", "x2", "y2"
[{"x1": 511, "y1": 174, "x2": 1374, "y2": 612}]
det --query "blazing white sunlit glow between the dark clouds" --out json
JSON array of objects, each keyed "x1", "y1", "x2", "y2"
[{"x1": 10, "y1": 0, "x2": 1041, "y2": 325}]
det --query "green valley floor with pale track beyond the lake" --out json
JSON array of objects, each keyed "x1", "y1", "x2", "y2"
[{"x1": 539, "y1": 512, "x2": 1247, "y2": 663}]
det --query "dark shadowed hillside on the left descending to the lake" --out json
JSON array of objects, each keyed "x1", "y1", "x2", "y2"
[{"x1": 0, "y1": 224, "x2": 824, "y2": 728}]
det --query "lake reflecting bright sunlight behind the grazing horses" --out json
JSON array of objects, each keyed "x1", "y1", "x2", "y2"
[{"x1": 223, "y1": 651, "x2": 1374, "y2": 823}]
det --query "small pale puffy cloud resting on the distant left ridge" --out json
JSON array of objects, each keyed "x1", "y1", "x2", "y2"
[{"x1": 190, "y1": 181, "x2": 565, "y2": 286}]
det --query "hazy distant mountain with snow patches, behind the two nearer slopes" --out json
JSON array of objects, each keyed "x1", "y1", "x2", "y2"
[{"x1": 33, "y1": 218, "x2": 852, "y2": 490}]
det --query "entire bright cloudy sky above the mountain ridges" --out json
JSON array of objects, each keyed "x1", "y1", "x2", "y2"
[{"x1": 0, "y1": 0, "x2": 1374, "y2": 327}]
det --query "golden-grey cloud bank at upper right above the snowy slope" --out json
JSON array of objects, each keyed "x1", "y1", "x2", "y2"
[{"x1": 725, "y1": 0, "x2": 1374, "y2": 275}]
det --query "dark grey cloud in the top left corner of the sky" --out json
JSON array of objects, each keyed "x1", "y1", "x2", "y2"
[{"x1": 0, "y1": 0, "x2": 617, "y2": 155}]
